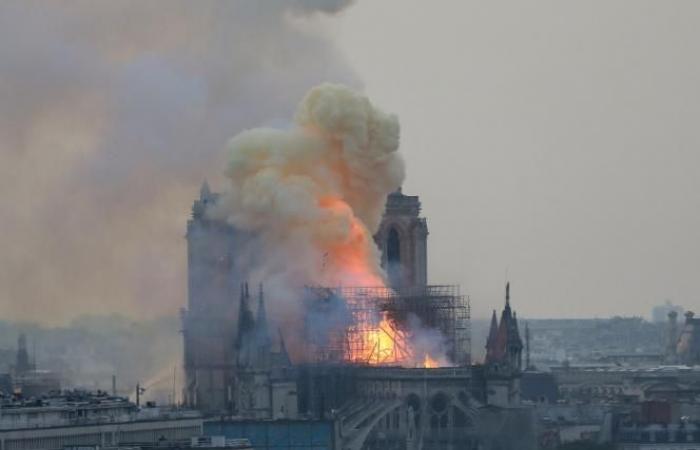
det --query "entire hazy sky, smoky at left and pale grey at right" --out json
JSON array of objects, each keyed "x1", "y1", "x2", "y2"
[{"x1": 0, "y1": 0, "x2": 700, "y2": 321}]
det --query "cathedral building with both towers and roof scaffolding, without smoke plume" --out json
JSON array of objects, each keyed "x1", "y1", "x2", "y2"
[{"x1": 182, "y1": 184, "x2": 534, "y2": 450}]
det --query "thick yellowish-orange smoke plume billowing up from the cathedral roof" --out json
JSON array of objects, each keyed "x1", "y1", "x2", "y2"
[{"x1": 213, "y1": 84, "x2": 404, "y2": 287}]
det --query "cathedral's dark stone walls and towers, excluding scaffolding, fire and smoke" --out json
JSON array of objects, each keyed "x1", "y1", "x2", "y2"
[{"x1": 183, "y1": 185, "x2": 532, "y2": 450}]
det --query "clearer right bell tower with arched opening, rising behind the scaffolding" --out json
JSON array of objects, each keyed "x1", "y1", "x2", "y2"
[{"x1": 374, "y1": 188, "x2": 428, "y2": 289}]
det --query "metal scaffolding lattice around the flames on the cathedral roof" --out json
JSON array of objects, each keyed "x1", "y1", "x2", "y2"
[{"x1": 304, "y1": 285, "x2": 471, "y2": 366}]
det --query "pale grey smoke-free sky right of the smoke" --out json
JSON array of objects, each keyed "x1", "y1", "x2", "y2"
[{"x1": 330, "y1": 0, "x2": 700, "y2": 317}]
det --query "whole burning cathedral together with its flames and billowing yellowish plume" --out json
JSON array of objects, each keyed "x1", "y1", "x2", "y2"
[{"x1": 182, "y1": 86, "x2": 532, "y2": 450}]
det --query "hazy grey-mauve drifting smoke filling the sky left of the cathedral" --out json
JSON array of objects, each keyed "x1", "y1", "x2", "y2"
[{"x1": 0, "y1": 0, "x2": 358, "y2": 322}]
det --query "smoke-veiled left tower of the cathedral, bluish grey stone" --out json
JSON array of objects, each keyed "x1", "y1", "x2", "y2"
[{"x1": 181, "y1": 183, "x2": 245, "y2": 412}]
